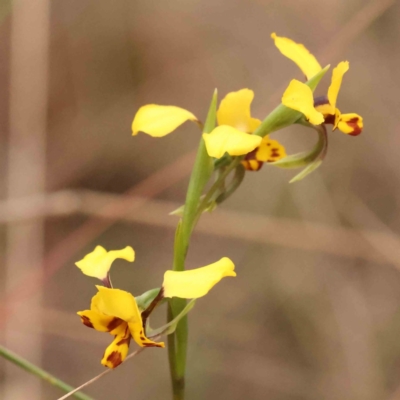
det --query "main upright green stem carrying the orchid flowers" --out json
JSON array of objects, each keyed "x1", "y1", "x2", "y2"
[{"x1": 168, "y1": 91, "x2": 217, "y2": 400}]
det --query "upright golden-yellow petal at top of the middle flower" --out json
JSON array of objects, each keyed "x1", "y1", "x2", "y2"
[{"x1": 217, "y1": 89, "x2": 261, "y2": 133}]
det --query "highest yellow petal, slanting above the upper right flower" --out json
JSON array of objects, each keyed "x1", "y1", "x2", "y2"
[{"x1": 271, "y1": 33, "x2": 322, "y2": 79}]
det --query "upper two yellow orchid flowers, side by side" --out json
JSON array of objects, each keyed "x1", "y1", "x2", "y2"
[{"x1": 132, "y1": 33, "x2": 363, "y2": 180}]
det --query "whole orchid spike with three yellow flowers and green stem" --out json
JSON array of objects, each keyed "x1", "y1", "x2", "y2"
[{"x1": 76, "y1": 33, "x2": 363, "y2": 399}]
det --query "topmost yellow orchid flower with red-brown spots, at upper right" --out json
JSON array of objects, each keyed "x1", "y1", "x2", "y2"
[{"x1": 271, "y1": 33, "x2": 363, "y2": 136}]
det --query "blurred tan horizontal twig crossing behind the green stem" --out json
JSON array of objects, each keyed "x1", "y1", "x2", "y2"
[{"x1": 0, "y1": 191, "x2": 400, "y2": 269}]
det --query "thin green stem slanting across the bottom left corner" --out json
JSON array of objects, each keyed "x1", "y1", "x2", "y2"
[{"x1": 0, "y1": 346, "x2": 93, "y2": 400}]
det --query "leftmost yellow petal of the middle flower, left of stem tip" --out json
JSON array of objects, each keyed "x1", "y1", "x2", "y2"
[{"x1": 132, "y1": 104, "x2": 197, "y2": 137}]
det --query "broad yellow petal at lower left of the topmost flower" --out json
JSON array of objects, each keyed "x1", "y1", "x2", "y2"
[{"x1": 282, "y1": 79, "x2": 324, "y2": 125}]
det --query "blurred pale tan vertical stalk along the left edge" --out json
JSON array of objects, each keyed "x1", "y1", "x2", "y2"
[{"x1": 2, "y1": 0, "x2": 50, "y2": 400}]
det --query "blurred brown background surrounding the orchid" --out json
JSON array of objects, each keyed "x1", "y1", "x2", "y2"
[{"x1": 0, "y1": 0, "x2": 400, "y2": 400}]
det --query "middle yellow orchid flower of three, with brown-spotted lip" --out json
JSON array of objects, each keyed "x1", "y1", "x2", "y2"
[{"x1": 132, "y1": 89, "x2": 286, "y2": 169}]
